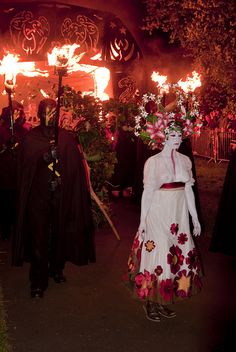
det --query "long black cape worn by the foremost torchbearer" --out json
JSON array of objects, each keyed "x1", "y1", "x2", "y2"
[{"x1": 12, "y1": 126, "x2": 95, "y2": 266}]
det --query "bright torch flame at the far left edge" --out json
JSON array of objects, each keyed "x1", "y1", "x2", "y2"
[{"x1": 0, "y1": 53, "x2": 48, "y2": 89}]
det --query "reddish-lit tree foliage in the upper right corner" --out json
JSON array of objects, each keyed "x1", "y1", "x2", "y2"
[{"x1": 142, "y1": 0, "x2": 236, "y2": 111}]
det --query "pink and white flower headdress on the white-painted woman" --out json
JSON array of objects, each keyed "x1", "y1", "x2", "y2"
[{"x1": 134, "y1": 85, "x2": 202, "y2": 149}]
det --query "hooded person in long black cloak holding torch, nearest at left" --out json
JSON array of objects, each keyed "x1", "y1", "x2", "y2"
[{"x1": 13, "y1": 99, "x2": 95, "y2": 297}]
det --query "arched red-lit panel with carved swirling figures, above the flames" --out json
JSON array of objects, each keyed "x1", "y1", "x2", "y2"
[{"x1": 0, "y1": 2, "x2": 141, "y2": 63}]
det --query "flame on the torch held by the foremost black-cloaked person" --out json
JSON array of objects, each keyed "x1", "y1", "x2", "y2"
[{"x1": 47, "y1": 44, "x2": 84, "y2": 73}]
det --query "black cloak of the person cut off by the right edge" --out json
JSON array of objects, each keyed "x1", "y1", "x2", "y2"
[{"x1": 210, "y1": 149, "x2": 236, "y2": 256}]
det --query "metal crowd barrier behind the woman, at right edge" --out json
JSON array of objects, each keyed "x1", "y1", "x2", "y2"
[{"x1": 192, "y1": 128, "x2": 236, "y2": 163}]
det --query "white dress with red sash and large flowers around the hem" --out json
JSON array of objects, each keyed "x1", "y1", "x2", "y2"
[{"x1": 125, "y1": 151, "x2": 201, "y2": 304}]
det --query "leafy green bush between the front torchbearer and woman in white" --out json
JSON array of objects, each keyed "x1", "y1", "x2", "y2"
[{"x1": 61, "y1": 86, "x2": 137, "y2": 225}]
